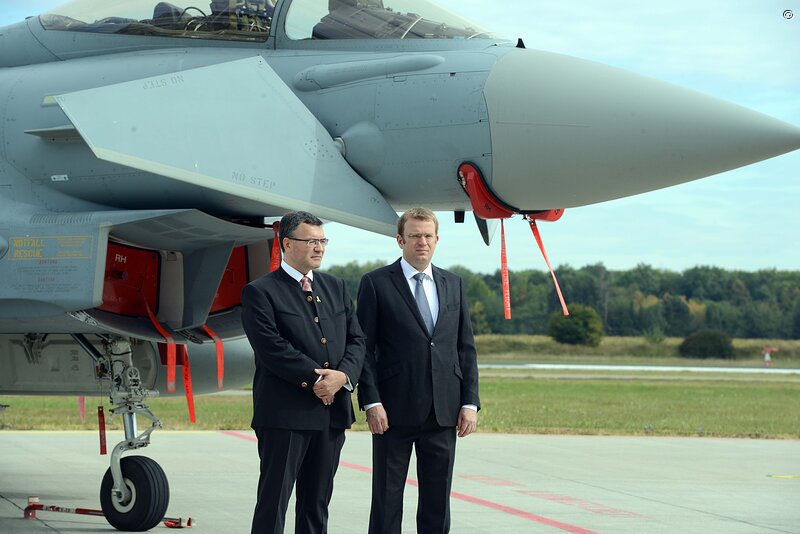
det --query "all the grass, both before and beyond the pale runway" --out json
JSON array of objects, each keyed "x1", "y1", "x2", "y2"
[{"x1": 0, "y1": 335, "x2": 800, "y2": 439}]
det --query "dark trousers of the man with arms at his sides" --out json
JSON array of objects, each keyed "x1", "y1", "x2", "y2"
[{"x1": 369, "y1": 412, "x2": 456, "y2": 534}]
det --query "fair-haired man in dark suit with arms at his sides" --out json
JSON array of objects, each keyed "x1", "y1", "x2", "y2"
[{"x1": 358, "y1": 208, "x2": 480, "y2": 534}]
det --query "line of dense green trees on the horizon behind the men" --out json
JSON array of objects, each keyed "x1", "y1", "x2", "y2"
[{"x1": 326, "y1": 261, "x2": 800, "y2": 339}]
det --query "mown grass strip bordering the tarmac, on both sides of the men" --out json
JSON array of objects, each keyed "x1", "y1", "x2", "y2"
[{"x1": 0, "y1": 373, "x2": 800, "y2": 439}]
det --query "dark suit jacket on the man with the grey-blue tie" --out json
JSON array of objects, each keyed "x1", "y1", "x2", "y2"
[{"x1": 358, "y1": 260, "x2": 480, "y2": 427}]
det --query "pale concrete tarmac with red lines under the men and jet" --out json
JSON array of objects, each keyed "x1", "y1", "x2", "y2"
[{"x1": 0, "y1": 430, "x2": 800, "y2": 534}]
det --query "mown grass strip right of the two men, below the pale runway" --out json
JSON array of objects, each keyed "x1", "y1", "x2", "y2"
[{"x1": 480, "y1": 378, "x2": 800, "y2": 439}]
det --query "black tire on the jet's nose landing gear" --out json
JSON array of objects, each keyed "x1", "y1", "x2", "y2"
[{"x1": 100, "y1": 456, "x2": 169, "y2": 532}]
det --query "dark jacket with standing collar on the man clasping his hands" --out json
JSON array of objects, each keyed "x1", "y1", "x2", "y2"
[{"x1": 242, "y1": 269, "x2": 364, "y2": 430}]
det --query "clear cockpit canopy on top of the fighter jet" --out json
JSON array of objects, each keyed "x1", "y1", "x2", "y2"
[{"x1": 39, "y1": 0, "x2": 494, "y2": 41}]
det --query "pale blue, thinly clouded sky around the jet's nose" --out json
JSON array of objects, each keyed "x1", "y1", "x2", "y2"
[{"x1": 0, "y1": 0, "x2": 800, "y2": 272}]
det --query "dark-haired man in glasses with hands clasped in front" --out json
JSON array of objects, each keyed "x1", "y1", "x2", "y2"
[{"x1": 242, "y1": 211, "x2": 364, "y2": 534}]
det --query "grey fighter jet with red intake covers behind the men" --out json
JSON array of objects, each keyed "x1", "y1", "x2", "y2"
[{"x1": 0, "y1": 0, "x2": 800, "y2": 530}]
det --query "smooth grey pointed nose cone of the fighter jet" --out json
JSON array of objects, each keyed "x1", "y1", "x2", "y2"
[{"x1": 484, "y1": 50, "x2": 800, "y2": 210}]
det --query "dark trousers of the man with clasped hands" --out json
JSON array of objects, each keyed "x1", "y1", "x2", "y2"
[{"x1": 251, "y1": 428, "x2": 344, "y2": 534}]
